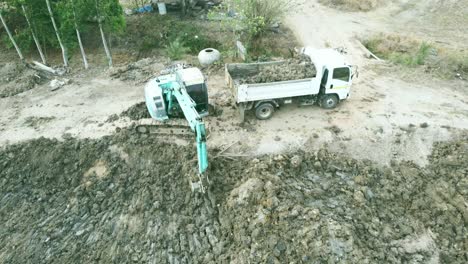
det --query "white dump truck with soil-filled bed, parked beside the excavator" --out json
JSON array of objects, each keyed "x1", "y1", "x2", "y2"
[{"x1": 226, "y1": 47, "x2": 357, "y2": 121}]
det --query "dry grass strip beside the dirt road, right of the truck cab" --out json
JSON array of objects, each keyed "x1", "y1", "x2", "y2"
[{"x1": 363, "y1": 34, "x2": 468, "y2": 78}]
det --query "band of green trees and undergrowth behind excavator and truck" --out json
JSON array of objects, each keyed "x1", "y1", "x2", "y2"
[{"x1": 0, "y1": 0, "x2": 298, "y2": 64}]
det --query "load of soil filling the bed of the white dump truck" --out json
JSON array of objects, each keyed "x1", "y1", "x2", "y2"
[{"x1": 229, "y1": 54, "x2": 317, "y2": 84}]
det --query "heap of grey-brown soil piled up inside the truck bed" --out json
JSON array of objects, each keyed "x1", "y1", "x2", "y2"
[{"x1": 235, "y1": 55, "x2": 317, "y2": 84}]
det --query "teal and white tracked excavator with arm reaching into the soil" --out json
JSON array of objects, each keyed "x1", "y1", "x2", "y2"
[{"x1": 137, "y1": 65, "x2": 209, "y2": 192}]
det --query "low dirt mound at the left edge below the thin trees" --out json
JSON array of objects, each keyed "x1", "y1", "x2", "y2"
[{"x1": 0, "y1": 62, "x2": 45, "y2": 98}]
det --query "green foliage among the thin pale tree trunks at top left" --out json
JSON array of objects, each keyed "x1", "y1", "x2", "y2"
[{"x1": 0, "y1": 0, "x2": 125, "y2": 65}]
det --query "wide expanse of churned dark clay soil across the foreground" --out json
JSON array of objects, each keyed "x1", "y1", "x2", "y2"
[{"x1": 0, "y1": 130, "x2": 468, "y2": 263}]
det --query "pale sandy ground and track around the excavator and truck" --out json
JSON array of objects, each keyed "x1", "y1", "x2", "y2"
[{"x1": 0, "y1": 1, "x2": 468, "y2": 165}]
